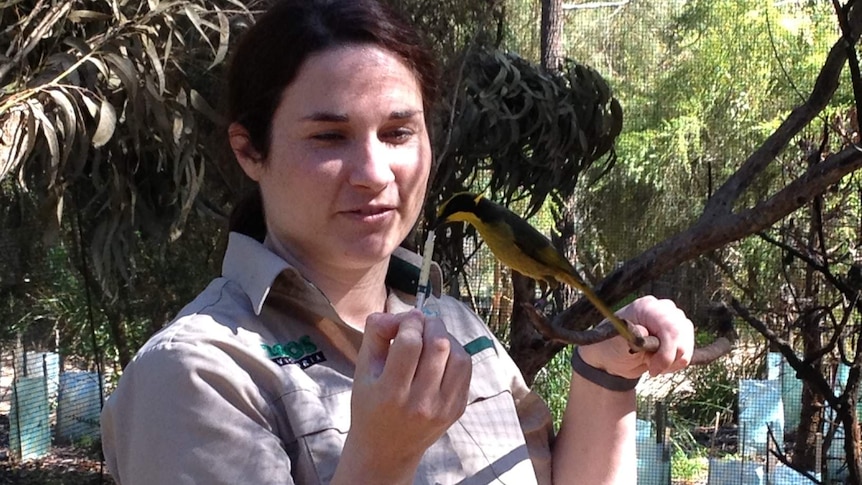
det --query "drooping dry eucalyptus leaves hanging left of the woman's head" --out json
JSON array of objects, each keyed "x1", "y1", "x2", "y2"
[{"x1": 0, "y1": 0, "x2": 254, "y2": 363}]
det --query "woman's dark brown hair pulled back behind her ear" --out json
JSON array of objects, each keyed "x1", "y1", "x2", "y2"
[{"x1": 227, "y1": 0, "x2": 439, "y2": 241}]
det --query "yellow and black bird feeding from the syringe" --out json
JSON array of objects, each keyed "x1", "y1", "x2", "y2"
[{"x1": 435, "y1": 192, "x2": 643, "y2": 348}]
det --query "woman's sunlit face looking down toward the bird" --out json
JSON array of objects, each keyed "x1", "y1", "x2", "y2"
[{"x1": 241, "y1": 44, "x2": 431, "y2": 270}]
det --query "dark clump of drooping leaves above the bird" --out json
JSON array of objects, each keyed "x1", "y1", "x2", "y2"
[{"x1": 432, "y1": 47, "x2": 623, "y2": 216}]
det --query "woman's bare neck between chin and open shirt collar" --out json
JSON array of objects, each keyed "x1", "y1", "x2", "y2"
[{"x1": 265, "y1": 236, "x2": 389, "y2": 330}]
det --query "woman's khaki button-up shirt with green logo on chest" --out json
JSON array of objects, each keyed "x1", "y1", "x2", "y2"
[{"x1": 102, "y1": 233, "x2": 552, "y2": 485}]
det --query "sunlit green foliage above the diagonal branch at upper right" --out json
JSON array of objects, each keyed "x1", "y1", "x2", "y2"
[{"x1": 567, "y1": 0, "x2": 840, "y2": 260}]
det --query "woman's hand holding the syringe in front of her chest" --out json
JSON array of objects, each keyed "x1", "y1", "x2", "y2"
[{"x1": 332, "y1": 310, "x2": 472, "y2": 484}]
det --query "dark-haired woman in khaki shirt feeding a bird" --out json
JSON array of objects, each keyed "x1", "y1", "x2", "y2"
[{"x1": 102, "y1": 0, "x2": 693, "y2": 485}]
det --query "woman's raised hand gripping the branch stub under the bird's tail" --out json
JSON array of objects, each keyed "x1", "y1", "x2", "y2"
[{"x1": 578, "y1": 296, "x2": 694, "y2": 379}]
